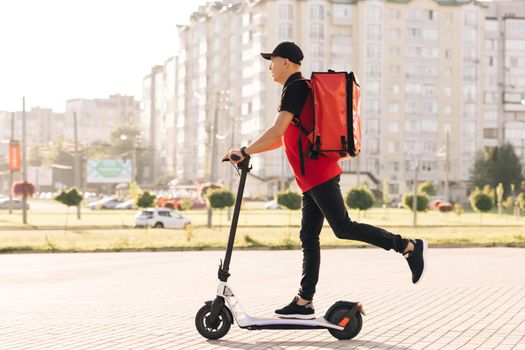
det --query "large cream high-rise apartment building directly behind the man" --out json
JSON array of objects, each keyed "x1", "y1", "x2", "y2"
[{"x1": 167, "y1": 0, "x2": 492, "y2": 199}]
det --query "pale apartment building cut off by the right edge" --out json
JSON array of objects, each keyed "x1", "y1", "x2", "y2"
[{"x1": 482, "y1": 1, "x2": 525, "y2": 162}]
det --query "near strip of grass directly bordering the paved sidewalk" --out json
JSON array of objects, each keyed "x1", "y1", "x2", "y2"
[{"x1": 0, "y1": 226, "x2": 525, "y2": 253}]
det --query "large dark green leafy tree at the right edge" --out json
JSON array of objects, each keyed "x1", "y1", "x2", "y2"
[{"x1": 472, "y1": 144, "x2": 523, "y2": 195}]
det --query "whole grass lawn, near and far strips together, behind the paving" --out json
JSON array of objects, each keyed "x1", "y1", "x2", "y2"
[{"x1": 0, "y1": 207, "x2": 525, "y2": 252}]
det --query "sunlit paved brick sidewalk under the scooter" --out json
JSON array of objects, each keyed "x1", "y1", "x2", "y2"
[{"x1": 0, "y1": 248, "x2": 525, "y2": 350}]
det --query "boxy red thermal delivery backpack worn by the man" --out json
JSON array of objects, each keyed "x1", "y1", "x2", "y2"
[{"x1": 292, "y1": 70, "x2": 361, "y2": 175}]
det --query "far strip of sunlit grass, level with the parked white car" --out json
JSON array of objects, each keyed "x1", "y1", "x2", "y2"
[{"x1": 0, "y1": 208, "x2": 525, "y2": 230}]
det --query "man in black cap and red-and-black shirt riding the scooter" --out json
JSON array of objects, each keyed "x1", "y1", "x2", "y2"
[{"x1": 223, "y1": 42, "x2": 427, "y2": 319}]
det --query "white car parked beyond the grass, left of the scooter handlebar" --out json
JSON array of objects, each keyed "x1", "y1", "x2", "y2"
[{"x1": 135, "y1": 208, "x2": 191, "y2": 228}]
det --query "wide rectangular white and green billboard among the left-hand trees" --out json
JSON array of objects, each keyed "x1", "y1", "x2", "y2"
[{"x1": 87, "y1": 159, "x2": 132, "y2": 184}]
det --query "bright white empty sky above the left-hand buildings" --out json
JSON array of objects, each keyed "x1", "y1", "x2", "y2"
[{"x1": 0, "y1": 0, "x2": 207, "y2": 112}]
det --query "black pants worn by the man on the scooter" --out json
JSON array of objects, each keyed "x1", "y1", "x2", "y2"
[{"x1": 299, "y1": 176, "x2": 408, "y2": 300}]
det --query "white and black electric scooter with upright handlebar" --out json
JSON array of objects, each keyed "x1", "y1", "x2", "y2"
[{"x1": 195, "y1": 155, "x2": 365, "y2": 339}]
